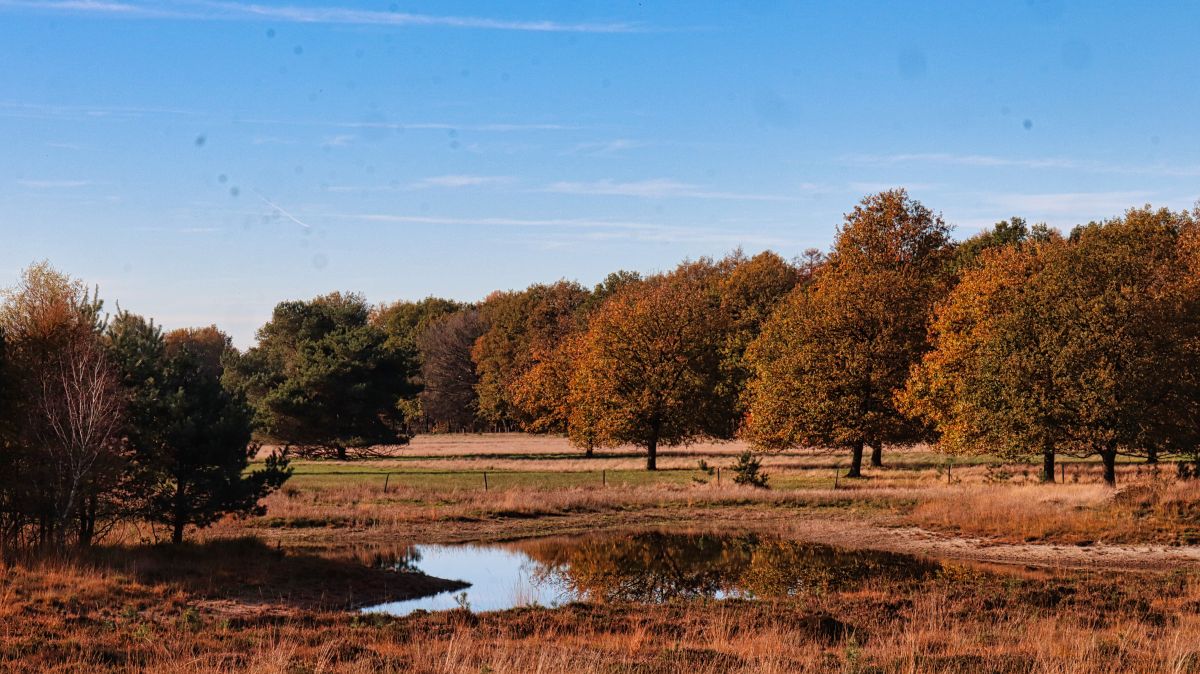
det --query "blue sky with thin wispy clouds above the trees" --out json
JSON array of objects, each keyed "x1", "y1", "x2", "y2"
[{"x1": 0, "y1": 0, "x2": 1200, "y2": 347}]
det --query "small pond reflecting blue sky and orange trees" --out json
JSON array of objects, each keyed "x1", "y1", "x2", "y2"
[{"x1": 364, "y1": 531, "x2": 941, "y2": 615}]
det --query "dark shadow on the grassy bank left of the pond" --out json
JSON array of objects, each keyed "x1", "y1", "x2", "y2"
[{"x1": 85, "y1": 537, "x2": 467, "y2": 610}]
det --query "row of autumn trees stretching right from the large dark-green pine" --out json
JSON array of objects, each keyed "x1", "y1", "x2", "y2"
[{"x1": 345, "y1": 189, "x2": 1200, "y2": 483}]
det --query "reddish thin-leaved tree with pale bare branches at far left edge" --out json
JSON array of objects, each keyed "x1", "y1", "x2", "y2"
[{"x1": 0, "y1": 263, "x2": 126, "y2": 546}]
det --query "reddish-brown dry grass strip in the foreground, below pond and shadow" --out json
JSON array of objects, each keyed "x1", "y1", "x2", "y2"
[{"x1": 7, "y1": 551, "x2": 1200, "y2": 674}]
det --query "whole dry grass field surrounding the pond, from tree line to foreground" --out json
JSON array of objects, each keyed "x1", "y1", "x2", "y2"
[{"x1": 0, "y1": 435, "x2": 1200, "y2": 673}]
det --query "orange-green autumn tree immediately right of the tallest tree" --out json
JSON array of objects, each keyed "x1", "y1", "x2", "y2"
[{"x1": 898, "y1": 237, "x2": 1069, "y2": 481}]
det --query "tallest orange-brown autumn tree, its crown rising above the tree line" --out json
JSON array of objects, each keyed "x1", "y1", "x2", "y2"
[{"x1": 746, "y1": 189, "x2": 950, "y2": 477}]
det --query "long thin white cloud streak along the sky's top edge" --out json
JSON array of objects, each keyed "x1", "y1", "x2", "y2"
[{"x1": 0, "y1": 0, "x2": 647, "y2": 34}]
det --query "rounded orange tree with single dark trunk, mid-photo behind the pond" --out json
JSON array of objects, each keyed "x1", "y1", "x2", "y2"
[{"x1": 571, "y1": 265, "x2": 725, "y2": 470}]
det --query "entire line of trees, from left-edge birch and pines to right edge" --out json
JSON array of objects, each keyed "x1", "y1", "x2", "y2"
[{"x1": 0, "y1": 189, "x2": 1200, "y2": 547}]
